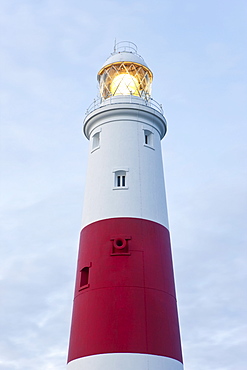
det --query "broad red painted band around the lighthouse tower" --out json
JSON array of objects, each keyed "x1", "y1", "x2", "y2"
[{"x1": 68, "y1": 218, "x2": 182, "y2": 362}]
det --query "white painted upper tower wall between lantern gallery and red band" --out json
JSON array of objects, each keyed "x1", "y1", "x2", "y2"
[{"x1": 83, "y1": 99, "x2": 168, "y2": 228}]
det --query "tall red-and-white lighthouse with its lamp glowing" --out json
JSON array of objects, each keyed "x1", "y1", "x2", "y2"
[{"x1": 67, "y1": 42, "x2": 183, "y2": 370}]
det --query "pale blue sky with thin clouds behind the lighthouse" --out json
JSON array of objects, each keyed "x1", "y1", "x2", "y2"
[{"x1": 0, "y1": 0, "x2": 247, "y2": 370}]
